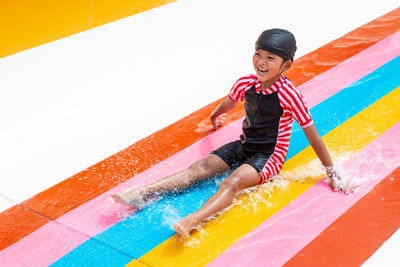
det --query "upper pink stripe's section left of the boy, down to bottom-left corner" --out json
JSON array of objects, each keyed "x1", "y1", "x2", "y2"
[{"x1": 0, "y1": 120, "x2": 241, "y2": 267}]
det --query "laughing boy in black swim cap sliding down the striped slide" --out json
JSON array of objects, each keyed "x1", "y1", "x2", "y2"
[{"x1": 111, "y1": 29, "x2": 348, "y2": 238}]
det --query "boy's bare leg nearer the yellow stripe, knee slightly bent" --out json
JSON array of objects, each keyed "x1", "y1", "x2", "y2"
[{"x1": 174, "y1": 164, "x2": 261, "y2": 238}]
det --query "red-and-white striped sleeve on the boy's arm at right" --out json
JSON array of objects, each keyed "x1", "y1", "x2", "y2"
[{"x1": 282, "y1": 81, "x2": 313, "y2": 129}]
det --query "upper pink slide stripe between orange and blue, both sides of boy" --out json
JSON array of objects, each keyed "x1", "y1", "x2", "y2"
[{"x1": 0, "y1": 32, "x2": 400, "y2": 266}]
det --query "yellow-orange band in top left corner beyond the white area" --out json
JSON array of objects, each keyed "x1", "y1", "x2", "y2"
[{"x1": 0, "y1": 0, "x2": 176, "y2": 58}]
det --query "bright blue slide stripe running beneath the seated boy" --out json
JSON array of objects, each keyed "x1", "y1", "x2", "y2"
[{"x1": 53, "y1": 57, "x2": 400, "y2": 266}]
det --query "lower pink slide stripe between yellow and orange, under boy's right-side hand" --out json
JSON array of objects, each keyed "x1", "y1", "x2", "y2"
[{"x1": 207, "y1": 117, "x2": 400, "y2": 266}]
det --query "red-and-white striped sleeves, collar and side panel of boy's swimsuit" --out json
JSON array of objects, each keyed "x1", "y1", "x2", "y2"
[{"x1": 228, "y1": 74, "x2": 313, "y2": 182}]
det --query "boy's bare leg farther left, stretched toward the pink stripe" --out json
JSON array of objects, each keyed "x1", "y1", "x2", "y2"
[{"x1": 110, "y1": 154, "x2": 229, "y2": 208}]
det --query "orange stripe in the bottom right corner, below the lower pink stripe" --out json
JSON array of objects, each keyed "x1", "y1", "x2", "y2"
[{"x1": 285, "y1": 167, "x2": 400, "y2": 266}]
